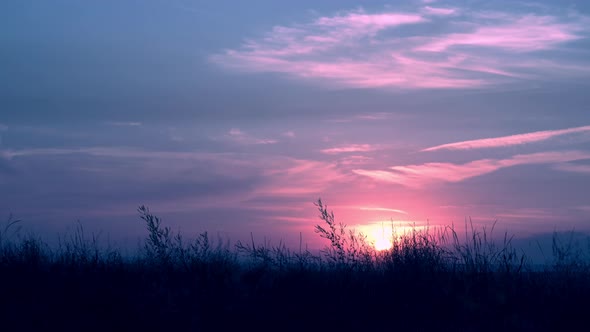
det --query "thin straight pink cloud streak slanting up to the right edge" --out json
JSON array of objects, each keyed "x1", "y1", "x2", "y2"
[{"x1": 421, "y1": 126, "x2": 590, "y2": 152}]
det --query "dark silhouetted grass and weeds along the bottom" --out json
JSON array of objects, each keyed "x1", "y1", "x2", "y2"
[{"x1": 0, "y1": 201, "x2": 590, "y2": 331}]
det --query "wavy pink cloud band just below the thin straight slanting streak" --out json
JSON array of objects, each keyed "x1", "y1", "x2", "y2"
[{"x1": 353, "y1": 151, "x2": 590, "y2": 187}]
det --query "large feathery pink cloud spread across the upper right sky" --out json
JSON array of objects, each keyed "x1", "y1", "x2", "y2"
[{"x1": 210, "y1": 4, "x2": 590, "y2": 89}]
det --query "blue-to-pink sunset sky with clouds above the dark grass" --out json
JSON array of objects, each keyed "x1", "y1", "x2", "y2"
[{"x1": 0, "y1": 0, "x2": 590, "y2": 250}]
